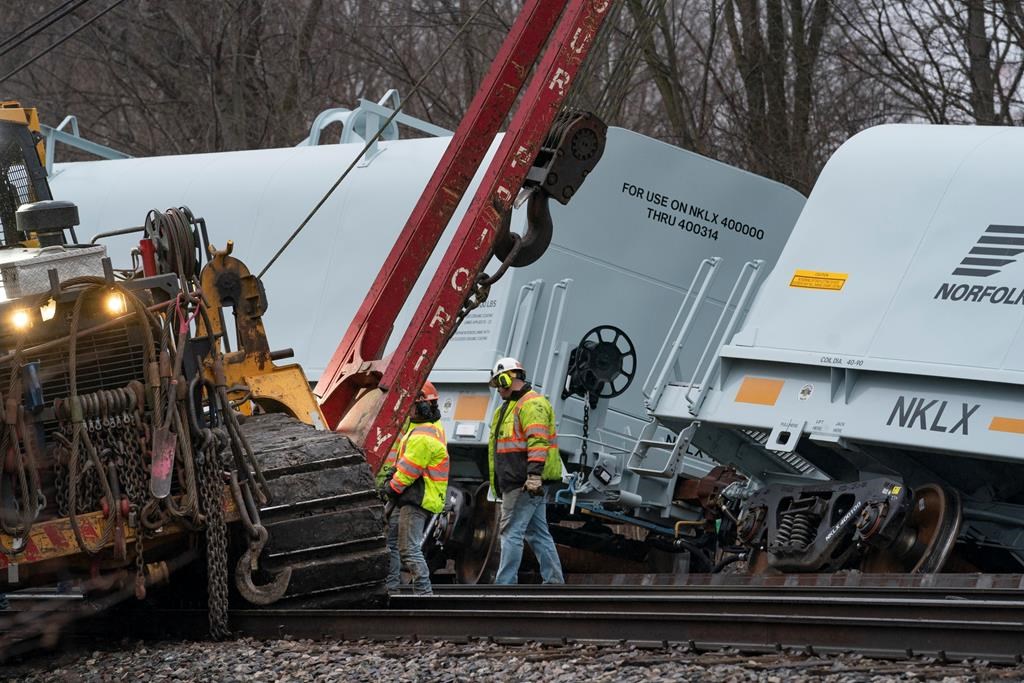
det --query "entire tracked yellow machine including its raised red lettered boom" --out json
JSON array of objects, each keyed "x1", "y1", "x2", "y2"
[{"x1": 0, "y1": 0, "x2": 610, "y2": 647}]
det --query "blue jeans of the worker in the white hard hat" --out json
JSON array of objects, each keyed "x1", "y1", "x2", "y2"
[{"x1": 495, "y1": 488, "x2": 565, "y2": 584}]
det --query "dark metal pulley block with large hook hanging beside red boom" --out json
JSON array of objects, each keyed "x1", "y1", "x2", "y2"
[{"x1": 495, "y1": 110, "x2": 608, "y2": 267}]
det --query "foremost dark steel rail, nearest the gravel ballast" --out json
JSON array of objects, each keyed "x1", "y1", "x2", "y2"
[{"x1": 232, "y1": 608, "x2": 1024, "y2": 663}]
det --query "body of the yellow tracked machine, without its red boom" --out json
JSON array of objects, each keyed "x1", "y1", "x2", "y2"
[{"x1": 0, "y1": 102, "x2": 386, "y2": 635}]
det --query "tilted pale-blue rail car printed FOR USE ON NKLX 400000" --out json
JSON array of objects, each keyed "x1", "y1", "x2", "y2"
[{"x1": 50, "y1": 128, "x2": 804, "y2": 471}]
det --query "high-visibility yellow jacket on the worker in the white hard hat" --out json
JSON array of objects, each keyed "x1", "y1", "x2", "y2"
[{"x1": 487, "y1": 387, "x2": 562, "y2": 496}]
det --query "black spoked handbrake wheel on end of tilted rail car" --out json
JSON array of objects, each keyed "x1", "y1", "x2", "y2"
[{"x1": 562, "y1": 325, "x2": 637, "y2": 408}]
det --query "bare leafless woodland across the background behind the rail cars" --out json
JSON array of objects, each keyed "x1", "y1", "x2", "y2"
[{"x1": 0, "y1": 0, "x2": 1024, "y2": 193}]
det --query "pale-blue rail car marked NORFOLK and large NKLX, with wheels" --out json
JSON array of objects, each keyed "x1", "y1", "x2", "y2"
[{"x1": 653, "y1": 125, "x2": 1024, "y2": 571}]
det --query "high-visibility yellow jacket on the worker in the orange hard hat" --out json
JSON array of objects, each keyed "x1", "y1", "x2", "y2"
[{"x1": 388, "y1": 421, "x2": 449, "y2": 512}]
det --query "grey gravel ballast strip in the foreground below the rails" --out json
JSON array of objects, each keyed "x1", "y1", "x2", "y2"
[{"x1": 0, "y1": 639, "x2": 1024, "y2": 683}]
